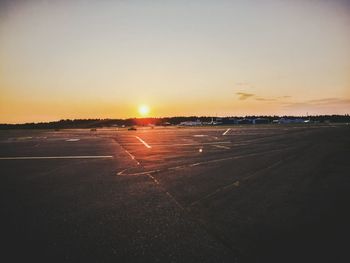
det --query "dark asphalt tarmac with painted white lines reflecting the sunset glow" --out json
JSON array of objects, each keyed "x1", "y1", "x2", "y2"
[{"x1": 0, "y1": 124, "x2": 350, "y2": 262}]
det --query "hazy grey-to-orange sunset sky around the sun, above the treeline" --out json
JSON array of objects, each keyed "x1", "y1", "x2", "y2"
[{"x1": 0, "y1": 0, "x2": 350, "y2": 123}]
